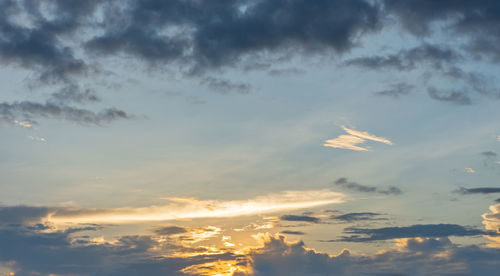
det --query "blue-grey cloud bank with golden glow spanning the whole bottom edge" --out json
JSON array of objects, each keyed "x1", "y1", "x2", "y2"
[{"x1": 0, "y1": 206, "x2": 500, "y2": 276}]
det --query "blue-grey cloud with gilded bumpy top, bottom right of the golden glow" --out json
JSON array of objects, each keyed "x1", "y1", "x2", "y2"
[{"x1": 249, "y1": 236, "x2": 500, "y2": 276}]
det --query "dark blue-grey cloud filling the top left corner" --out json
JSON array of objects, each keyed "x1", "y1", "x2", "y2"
[{"x1": 0, "y1": 1, "x2": 98, "y2": 82}]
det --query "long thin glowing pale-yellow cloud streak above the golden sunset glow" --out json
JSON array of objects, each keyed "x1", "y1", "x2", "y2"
[{"x1": 49, "y1": 189, "x2": 346, "y2": 223}]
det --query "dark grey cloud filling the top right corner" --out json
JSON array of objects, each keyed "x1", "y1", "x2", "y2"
[{"x1": 384, "y1": 0, "x2": 500, "y2": 62}]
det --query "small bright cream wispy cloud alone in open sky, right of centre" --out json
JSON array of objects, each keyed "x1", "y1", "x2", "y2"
[{"x1": 323, "y1": 126, "x2": 392, "y2": 151}]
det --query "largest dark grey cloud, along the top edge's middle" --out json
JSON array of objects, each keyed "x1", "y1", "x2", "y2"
[{"x1": 87, "y1": 0, "x2": 379, "y2": 71}]
